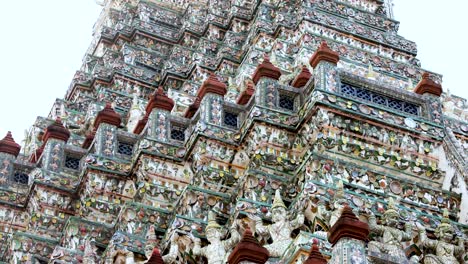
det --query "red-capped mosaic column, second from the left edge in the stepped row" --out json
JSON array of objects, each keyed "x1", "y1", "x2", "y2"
[{"x1": 37, "y1": 118, "x2": 70, "y2": 172}]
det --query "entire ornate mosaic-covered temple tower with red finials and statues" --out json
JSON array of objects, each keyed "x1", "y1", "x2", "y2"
[{"x1": 0, "y1": 0, "x2": 468, "y2": 264}]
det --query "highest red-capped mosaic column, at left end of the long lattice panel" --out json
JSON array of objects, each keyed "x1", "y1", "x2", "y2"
[{"x1": 309, "y1": 42, "x2": 341, "y2": 92}]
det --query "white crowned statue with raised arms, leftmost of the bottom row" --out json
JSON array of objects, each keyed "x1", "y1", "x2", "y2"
[{"x1": 192, "y1": 211, "x2": 241, "y2": 264}]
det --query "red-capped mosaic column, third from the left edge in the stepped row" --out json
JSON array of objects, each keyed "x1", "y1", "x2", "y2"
[{"x1": 94, "y1": 103, "x2": 121, "y2": 157}]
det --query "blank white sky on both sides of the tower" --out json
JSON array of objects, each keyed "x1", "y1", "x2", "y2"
[{"x1": 0, "y1": 0, "x2": 468, "y2": 147}]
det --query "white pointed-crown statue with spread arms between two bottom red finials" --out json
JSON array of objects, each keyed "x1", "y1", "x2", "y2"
[{"x1": 249, "y1": 190, "x2": 304, "y2": 257}]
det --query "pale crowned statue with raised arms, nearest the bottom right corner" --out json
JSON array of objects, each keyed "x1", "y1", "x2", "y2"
[{"x1": 417, "y1": 209, "x2": 465, "y2": 264}]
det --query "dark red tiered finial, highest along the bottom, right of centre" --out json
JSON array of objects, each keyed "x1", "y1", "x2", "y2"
[{"x1": 328, "y1": 205, "x2": 369, "y2": 245}]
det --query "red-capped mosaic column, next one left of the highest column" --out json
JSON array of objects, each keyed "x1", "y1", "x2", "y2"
[{"x1": 252, "y1": 55, "x2": 281, "y2": 107}]
